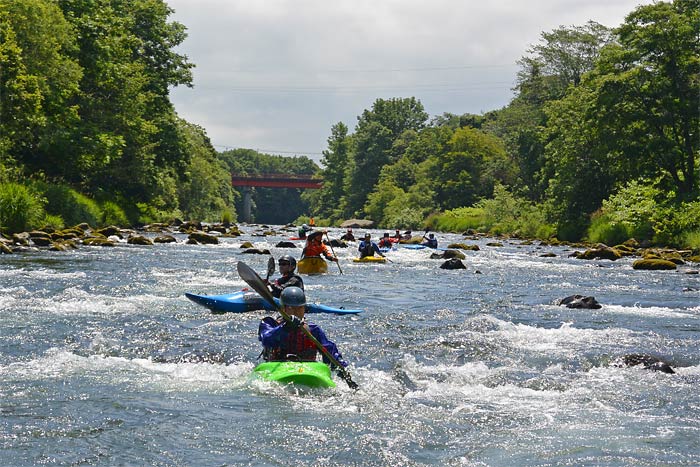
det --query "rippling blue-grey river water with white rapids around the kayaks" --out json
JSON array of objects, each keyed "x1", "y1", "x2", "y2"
[{"x1": 0, "y1": 226, "x2": 700, "y2": 467}]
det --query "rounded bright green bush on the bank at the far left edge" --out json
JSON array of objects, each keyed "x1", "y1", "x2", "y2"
[{"x1": 0, "y1": 183, "x2": 45, "y2": 233}]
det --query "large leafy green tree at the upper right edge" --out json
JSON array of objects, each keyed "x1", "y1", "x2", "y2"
[{"x1": 590, "y1": 0, "x2": 700, "y2": 198}]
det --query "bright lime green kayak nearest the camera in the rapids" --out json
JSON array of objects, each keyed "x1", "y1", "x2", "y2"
[{"x1": 253, "y1": 362, "x2": 335, "y2": 388}]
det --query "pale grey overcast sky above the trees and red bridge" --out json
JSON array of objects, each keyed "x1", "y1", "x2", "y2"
[{"x1": 166, "y1": 0, "x2": 653, "y2": 162}]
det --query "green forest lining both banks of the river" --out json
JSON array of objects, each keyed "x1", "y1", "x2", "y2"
[{"x1": 0, "y1": 0, "x2": 700, "y2": 249}]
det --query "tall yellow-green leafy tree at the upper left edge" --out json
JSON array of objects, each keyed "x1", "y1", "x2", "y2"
[{"x1": 0, "y1": 0, "x2": 82, "y2": 179}]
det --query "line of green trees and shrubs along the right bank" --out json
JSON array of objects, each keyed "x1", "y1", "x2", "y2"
[{"x1": 306, "y1": 0, "x2": 700, "y2": 248}]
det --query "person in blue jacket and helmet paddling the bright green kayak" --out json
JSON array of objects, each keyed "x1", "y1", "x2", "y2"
[{"x1": 258, "y1": 287, "x2": 348, "y2": 367}]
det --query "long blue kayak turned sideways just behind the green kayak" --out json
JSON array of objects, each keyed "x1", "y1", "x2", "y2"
[{"x1": 185, "y1": 290, "x2": 362, "y2": 315}]
